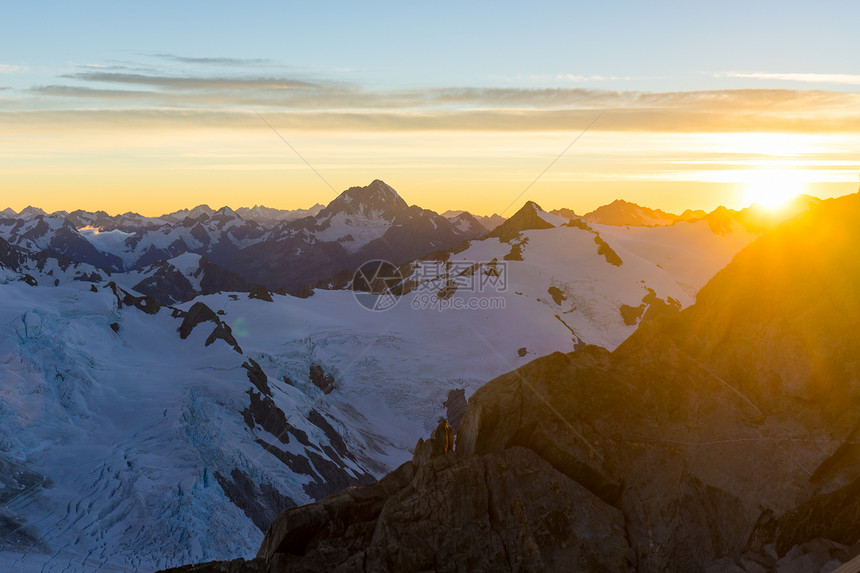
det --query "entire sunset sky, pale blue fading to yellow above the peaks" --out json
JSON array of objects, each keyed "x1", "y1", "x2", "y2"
[{"x1": 0, "y1": 1, "x2": 860, "y2": 216}]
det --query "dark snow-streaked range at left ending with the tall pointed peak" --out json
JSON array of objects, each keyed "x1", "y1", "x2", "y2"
[{"x1": 0, "y1": 180, "x2": 486, "y2": 294}]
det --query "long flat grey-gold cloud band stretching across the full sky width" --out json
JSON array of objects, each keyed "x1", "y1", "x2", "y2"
[{"x1": 5, "y1": 99, "x2": 860, "y2": 133}]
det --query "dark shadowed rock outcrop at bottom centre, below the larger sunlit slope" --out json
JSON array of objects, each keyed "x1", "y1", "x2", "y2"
[{"x1": 252, "y1": 422, "x2": 628, "y2": 572}]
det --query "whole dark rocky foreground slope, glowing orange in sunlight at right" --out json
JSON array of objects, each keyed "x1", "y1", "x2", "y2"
[{"x1": 166, "y1": 195, "x2": 860, "y2": 572}]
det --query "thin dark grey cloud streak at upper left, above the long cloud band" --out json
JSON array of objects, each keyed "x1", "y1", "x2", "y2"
[{"x1": 61, "y1": 71, "x2": 320, "y2": 90}]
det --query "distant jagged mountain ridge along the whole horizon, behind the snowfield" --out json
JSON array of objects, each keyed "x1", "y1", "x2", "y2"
[{"x1": 0, "y1": 187, "x2": 819, "y2": 302}]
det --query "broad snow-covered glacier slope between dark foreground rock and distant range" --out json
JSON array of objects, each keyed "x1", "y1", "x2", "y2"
[{"x1": 0, "y1": 194, "x2": 755, "y2": 571}]
